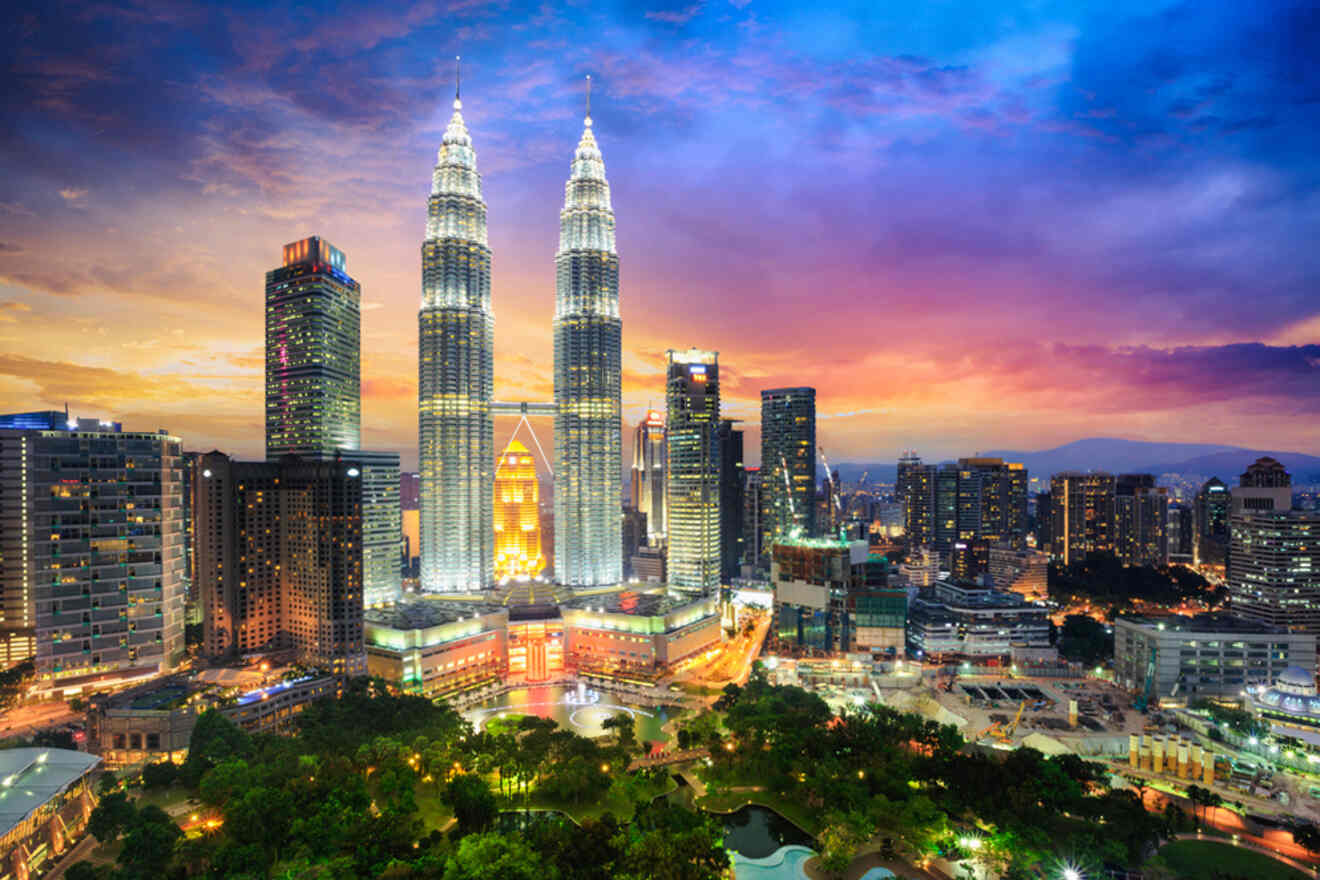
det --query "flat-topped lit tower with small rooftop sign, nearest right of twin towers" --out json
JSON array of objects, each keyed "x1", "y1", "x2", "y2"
[{"x1": 665, "y1": 348, "x2": 723, "y2": 592}]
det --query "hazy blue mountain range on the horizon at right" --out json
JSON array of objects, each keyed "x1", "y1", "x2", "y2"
[{"x1": 821, "y1": 437, "x2": 1320, "y2": 486}]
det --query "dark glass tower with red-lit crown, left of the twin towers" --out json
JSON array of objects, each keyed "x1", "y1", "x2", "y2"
[{"x1": 265, "y1": 235, "x2": 362, "y2": 459}]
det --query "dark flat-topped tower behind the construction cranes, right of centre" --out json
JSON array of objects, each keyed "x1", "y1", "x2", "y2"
[{"x1": 760, "y1": 388, "x2": 816, "y2": 551}]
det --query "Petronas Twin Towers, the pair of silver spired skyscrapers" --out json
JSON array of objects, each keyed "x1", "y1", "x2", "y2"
[{"x1": 417, "y1": 79, "x2": 623, "y2": 592}]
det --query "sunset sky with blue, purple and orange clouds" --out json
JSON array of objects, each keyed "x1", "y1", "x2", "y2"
[{"x1": 0, "y1": 0, "x2": 1320, "y2": 466}]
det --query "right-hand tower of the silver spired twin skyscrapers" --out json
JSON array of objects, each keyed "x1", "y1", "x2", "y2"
[{"x1": 554, "y1": 80, "x2": 623, "y2": 587}]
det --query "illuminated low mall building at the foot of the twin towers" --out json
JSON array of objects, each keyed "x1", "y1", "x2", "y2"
[{"x1": 366, "y1": 591, "x2": 721, "y2": 697}]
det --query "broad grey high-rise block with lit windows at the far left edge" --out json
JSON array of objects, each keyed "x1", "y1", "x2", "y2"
[{"x1": 0, "y1": 412, "x2": 185, "y2": 695}]
